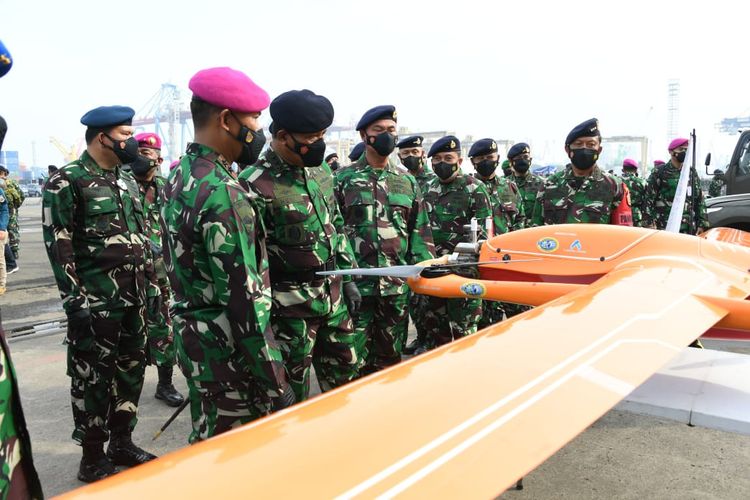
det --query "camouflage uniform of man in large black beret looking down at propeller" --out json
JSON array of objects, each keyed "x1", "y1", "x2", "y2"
[{"x1": 239, "y1": 149, "x2": 364, "y2": 401}]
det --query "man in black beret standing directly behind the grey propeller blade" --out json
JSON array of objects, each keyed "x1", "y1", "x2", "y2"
[{"x1": 336, "y1": 106, "x2": 434, "y2": 373}]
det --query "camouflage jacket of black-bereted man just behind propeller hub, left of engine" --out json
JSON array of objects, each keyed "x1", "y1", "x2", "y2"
[{"x1": 424, "y1": 175, "x2": 496, "y2": 256}]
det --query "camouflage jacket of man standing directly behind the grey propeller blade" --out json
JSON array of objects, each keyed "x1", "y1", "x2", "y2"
[{"x1": 335, "y1": 155, "x2": 434, "y2": 296}]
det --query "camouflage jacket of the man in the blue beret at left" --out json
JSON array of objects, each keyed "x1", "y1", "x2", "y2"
[{"x1": 42, "y1": 151, "x2": 156, "y2": 312}]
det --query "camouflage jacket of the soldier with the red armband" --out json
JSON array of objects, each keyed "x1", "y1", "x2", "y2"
[{"x1": 531, "y1": 165, "x2": 625, "y2": 226}]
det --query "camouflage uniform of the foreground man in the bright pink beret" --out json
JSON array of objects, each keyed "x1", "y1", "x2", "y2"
[{"x1": 161, "y1": 143, "x2": 288, "y2": 443}]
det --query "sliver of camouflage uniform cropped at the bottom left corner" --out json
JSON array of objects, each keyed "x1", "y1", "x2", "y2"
[{"x1": 0, "y1": 314, "x2": 44, "y2": 500}]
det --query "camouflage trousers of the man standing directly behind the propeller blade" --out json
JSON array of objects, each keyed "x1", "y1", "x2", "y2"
[{"x1": 354, "y1": 293, "x2": 409, "y2": 374}]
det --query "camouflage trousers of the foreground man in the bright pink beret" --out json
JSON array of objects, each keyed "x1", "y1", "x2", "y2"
[{"x1": 183, "y1": 372, "x2": 271, "y2": 444}]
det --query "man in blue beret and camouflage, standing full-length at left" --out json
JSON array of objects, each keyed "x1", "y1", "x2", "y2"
[{"x1": 42, "y1": 106, "x2": 158, "y2": 482}]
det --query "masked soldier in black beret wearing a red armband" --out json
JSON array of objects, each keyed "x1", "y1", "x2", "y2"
[{"x1": 531, "y1": 118, "x2": 633, "y2": 226}]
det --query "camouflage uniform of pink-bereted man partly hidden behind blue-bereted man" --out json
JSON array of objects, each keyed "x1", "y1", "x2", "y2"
[{"x1": 137, "y1": 175, "x2": 175, "y2": 367}]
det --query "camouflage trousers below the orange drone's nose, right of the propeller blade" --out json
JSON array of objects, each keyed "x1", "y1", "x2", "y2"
[{"x1": 425, "y1": 297, "x2": 482, "y2": 347}]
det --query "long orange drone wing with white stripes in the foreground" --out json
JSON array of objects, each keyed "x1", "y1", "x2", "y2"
[{"x1": 64, "y1": 257, "x2": 748, "y2": 498}]
